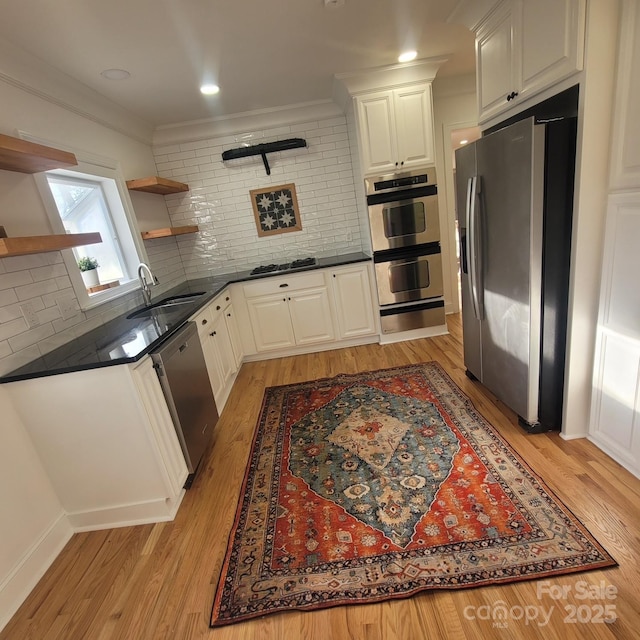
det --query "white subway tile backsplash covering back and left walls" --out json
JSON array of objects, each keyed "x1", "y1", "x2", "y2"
[{"x1": 0, "y1": 117, "x2": 368, "y2": 375}]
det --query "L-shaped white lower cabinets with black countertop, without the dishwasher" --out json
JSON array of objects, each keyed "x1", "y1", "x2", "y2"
[{"x1": 0, "y1": 252, "x2": 378, "y2": 531}]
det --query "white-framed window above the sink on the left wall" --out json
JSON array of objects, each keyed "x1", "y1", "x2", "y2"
[{"x1": 35, "y1": 148, "x2": 147, "y2": 309}]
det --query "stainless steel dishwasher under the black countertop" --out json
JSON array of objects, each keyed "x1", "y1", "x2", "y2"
[{"x1": 151, "y1": 322, "x2": 218, "y2": 488}]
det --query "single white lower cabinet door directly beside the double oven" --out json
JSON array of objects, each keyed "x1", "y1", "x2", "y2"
[{"x1": 332, "y1": 266, "x2": 375, "y2": 339}]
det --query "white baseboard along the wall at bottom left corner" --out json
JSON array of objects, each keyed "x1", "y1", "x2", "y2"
[{"x1": 0, "y1": 512, "x2": 74, "y2": 631}]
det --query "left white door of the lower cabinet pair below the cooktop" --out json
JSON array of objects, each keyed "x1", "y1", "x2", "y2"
[{"x1": 247, "y1": 294, "x2": 295, "y2": 351}]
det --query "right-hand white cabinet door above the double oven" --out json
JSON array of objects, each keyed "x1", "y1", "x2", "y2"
[{"x1": 394, "y1": 84, "x2": 435, "y2": 169}]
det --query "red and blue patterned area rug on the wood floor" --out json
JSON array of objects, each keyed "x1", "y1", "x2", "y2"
[{"x1": 211, "y1": 362, "x2": 615, "y2": 626}]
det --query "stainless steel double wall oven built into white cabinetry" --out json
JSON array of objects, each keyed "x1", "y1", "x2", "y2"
[{"x1": 365, "y1": 168, "x2": 445, "y2": 333}]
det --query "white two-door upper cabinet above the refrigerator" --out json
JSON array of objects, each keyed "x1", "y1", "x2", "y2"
[{"x1": 476, "y1": 0, "x2": 585, "y2": 122}]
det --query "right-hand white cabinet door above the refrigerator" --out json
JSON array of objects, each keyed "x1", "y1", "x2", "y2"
[{"x1": 520, "y1": 0, "x2": 585, "y2": 98}]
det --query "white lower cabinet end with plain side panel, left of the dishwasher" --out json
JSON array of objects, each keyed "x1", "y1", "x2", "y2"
[{"x1": 5, "y1": 357, "x2": 188, "y2": 531}]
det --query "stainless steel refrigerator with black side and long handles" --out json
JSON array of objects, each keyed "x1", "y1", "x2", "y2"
[{"x1": 456, "y1": 117, "x2": 576, "y2": 432}]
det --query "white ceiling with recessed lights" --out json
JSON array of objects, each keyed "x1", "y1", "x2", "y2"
[{"x1": 0, "y1": 0, "x2": 474, "y2": 126}]
